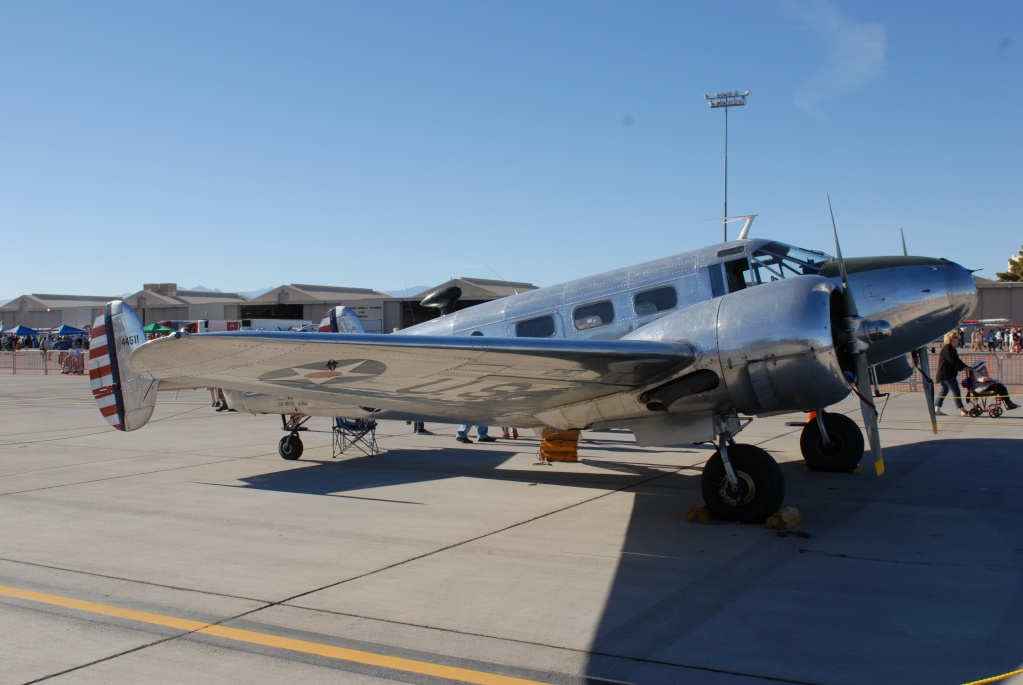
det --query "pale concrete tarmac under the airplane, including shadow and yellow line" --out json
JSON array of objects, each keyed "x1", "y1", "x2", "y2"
[{"x1": 0, "y1": 375, "x2": 1023, "y2": 685}]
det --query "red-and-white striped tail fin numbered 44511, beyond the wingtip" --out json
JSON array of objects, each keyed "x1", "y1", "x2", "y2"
[{"x1": 89, "y1": 300, "x2": 160, "y2": 430}]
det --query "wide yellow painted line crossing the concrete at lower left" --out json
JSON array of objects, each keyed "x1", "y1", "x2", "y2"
[{"x1": 0, "y1": 585, "x2": 543, "y2": 685}]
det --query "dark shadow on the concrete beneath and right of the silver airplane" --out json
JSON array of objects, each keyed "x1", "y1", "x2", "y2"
[{"x1": 211, "y1": 440, "x2": 1023, "y2": 683}]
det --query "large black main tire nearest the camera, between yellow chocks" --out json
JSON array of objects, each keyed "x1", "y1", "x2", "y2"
[{"x1": 700, "y1": 445, "x2": 785, "y2": 523}]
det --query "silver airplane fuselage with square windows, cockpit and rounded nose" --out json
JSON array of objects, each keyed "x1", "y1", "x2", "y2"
[{"x1": 398, "y1": 239, "x2": 976, "y2": 364}]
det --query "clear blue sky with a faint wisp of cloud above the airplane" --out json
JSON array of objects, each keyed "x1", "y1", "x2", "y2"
[{"x1": 0, "y1": 0, "x2": 1023, "y2": 302}]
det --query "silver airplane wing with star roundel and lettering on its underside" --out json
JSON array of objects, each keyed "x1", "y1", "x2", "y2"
[{"x1": 127, "y1": 331, "x2": 695, "y2": 421}]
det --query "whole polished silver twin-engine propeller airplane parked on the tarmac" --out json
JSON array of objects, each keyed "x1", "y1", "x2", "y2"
[{"x1": 89, "y1": 220, "x2": 977, "y2": 521}]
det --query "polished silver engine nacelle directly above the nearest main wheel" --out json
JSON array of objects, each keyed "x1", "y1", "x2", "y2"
[{"x1": 626, "y1": 276, "x2": 849, "y2": 415}]
